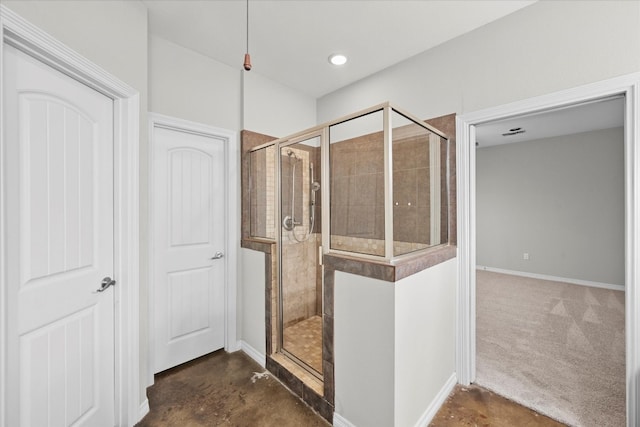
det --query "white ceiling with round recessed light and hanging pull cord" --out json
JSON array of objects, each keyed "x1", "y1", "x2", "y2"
[{"x1": 143, "y1": 0, "x2": 534, "y2": 98}]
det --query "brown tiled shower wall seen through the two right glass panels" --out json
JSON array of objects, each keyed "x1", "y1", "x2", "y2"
[{"x1": 330, "y1": 128, "x2": 447, "y2": 255}]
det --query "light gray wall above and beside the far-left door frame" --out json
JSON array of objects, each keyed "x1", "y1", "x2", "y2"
[{"x1": 0, "y1": 0, "x2": 149, "y2": 402}]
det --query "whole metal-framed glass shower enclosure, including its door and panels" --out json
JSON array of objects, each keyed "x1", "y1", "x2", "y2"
[{"x1": 250, "y1": 103, "x2": 449, "y2": 388}]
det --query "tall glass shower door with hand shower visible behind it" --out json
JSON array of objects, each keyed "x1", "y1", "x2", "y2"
[{"x1": 279, "y1": 135, "x2": 322, "y2": 377}]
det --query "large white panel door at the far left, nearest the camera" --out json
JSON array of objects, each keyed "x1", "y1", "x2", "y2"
[{"x1": 2, "y1": 46, "x2": 115, "y2": 427}]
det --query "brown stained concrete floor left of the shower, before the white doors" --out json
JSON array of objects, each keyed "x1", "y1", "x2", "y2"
[{"x1": 136, "y1": 350, "x2": 329, "y2": 427}]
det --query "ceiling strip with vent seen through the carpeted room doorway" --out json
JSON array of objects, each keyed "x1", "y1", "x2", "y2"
[{"x1": 476, "y1": 96, "x2": 624, "y2": 148}]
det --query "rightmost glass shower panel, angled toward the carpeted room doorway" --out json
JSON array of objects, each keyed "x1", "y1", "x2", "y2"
[{"x1": 391, "y1": 110, "x2": 448, "y2": 256}]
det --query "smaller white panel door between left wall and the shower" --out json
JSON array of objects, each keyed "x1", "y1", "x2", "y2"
[{"x1": 152, "y1": 127, "x2": 226, "y2": 372}]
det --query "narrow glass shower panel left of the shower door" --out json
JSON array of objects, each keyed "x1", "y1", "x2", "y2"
[{"x1": 249, "y1": 145, "x2": 276, "y2": 240}]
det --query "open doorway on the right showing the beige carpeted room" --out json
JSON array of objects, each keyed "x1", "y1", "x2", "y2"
[{"x1": 475, "y1": 97, "x2": 625, "y2": 426}]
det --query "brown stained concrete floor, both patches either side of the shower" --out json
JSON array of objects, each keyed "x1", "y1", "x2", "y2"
[{"x1": 137, "y1": 350, "x2": 563, "y2": 427}]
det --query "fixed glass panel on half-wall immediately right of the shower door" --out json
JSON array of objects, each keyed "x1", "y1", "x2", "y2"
[{"x1": 329, "y1": 110, "x2": 385, "y2": 256}]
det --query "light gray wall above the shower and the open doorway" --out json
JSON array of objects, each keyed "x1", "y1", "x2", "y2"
[{"x1": 317, "y1": 1, "x2": 640, "y2": 123}]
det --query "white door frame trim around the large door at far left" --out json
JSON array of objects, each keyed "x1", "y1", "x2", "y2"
[{"x1": 0, "y1": 5, "x2": 141, "y2": 427}]
